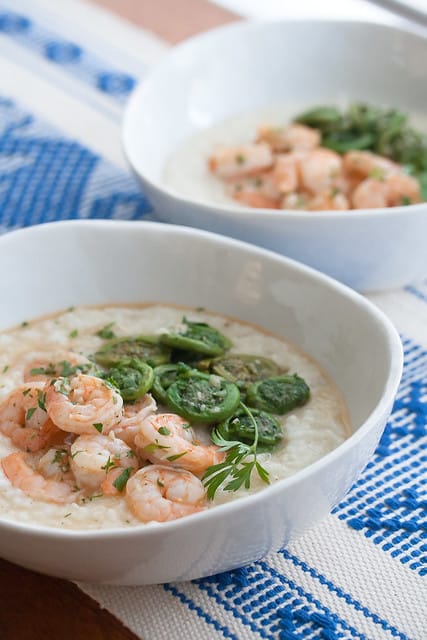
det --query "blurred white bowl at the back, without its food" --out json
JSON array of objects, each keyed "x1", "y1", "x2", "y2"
[{"x1": 123, "y1": 21, "x2": 427, "y2": 291}]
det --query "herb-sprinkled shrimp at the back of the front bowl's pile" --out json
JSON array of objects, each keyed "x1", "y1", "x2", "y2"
[{"x1": 24, "y1": 351, "x2": 92, "y2": 381}]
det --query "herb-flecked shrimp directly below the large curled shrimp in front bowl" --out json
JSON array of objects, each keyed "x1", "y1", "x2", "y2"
[{"x1": 70, "y1": 433, "x2": 138, "y2": 495}]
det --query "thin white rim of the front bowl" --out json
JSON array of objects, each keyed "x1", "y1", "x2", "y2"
[{"x1": 0, "y1": 220, "x2": 403, "y2": 541}]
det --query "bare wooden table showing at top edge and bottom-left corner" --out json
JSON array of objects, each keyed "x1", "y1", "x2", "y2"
[{"x1": 0, "y1": 0, "x2": 236, "y2": 640}]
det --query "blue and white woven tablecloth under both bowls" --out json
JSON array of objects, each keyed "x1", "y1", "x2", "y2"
[{"x1": 0, "y1": 0, "x2": 427, "y2": 640}]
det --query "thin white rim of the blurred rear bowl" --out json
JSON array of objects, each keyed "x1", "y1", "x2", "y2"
[{"x1": 121, "y1": 18, "x2": 427, "y2": 222}]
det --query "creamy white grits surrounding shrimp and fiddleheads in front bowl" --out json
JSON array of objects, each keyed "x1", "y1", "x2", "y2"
[{"x1": 0, "y1": 305, "x2": 350, "y2": 529}]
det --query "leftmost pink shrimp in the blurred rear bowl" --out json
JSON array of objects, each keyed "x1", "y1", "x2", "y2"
[{"x1": 208, "y1": 144, "x2": 273, "y2": 179}]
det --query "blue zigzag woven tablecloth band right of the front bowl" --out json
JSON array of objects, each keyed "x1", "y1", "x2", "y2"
[{"x1": 333, "y1": 339, "x2": 427, "y2": 575}]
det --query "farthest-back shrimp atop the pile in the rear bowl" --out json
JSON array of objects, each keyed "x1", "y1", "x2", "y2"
[{"x1": 257, "y1": 124, "x2": 321, "y2": 151}]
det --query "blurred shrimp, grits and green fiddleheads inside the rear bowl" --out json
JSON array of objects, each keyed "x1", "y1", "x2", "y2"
[{"x1": 166, "y1": 103, "x2": 427, "y2": 211}]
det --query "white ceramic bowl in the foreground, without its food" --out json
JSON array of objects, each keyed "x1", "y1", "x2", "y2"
[{"x1": 0, "y1": 221, "x2": 402, "y2": 584}]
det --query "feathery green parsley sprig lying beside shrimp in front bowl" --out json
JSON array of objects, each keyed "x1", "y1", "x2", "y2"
[{"x1": 202, "y1": 402, "x2": 270, "y2": 500}]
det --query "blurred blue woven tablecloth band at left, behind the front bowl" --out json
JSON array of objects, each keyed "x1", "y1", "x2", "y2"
[{"x1": 0, "y1": 98, "x2": 151, "y2": 230}]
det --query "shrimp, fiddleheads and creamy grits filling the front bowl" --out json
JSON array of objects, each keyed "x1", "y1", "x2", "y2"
[{"x1": 0, "y1": 304, "x2": 350, "y2": 530}]
